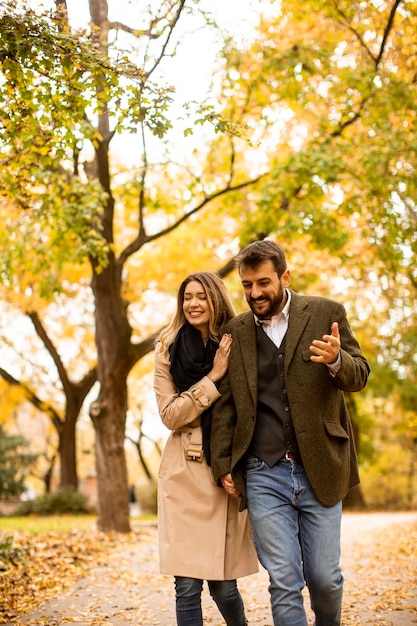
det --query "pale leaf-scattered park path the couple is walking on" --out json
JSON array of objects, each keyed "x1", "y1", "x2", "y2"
[{"x1": 9, "y1": 512, "x2": 417, "y2": 626}]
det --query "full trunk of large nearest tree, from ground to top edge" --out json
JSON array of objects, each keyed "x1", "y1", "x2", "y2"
[{"x1": 83, "y1": 0, "x2": 132, "y2": 532}]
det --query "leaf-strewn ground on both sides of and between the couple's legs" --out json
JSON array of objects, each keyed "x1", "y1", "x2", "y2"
[{"x1": 0, "y1": 515, "x2": 417, "y2": 626}]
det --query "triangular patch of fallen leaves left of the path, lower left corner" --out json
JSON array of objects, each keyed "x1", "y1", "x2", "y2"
[{"x1": 0, "y1": 530, "x2": 136, "y2": 624}]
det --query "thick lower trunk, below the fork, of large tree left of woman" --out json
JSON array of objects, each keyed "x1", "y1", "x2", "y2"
[{"x1": 90, "y1": 253, "x2": 131, "y2": 532}]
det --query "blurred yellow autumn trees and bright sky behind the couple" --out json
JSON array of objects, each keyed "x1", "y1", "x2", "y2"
[{"x1": 0, "y1": 0, "x2": 417, "y2": 528}]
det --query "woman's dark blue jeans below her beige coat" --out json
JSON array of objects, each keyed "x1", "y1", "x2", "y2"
[{"x1": 175, "y1": 576, "x2": 246, "y2": 626}]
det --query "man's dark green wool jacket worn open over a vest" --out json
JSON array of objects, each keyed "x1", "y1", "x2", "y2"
[{"x1": 211, "y1": 291, "x2": 370, "y2": 509}]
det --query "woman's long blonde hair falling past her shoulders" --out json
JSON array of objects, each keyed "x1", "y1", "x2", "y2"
[{"x1": 157, "y1": 272, "x2": 236, "y2": 359}]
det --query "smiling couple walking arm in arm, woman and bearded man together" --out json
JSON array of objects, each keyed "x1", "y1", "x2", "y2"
[{"x1": 154, "y1": 240, "x2": 369, "y2": 626}]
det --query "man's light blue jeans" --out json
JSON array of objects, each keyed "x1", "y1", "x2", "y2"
[{"x1": 246, "y1": 457, "x2": 343, "y2": 626}]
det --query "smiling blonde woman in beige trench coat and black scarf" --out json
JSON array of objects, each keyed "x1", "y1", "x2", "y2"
[{"x1": 154, "y1": 272, "x2": 258, "y2": 626}]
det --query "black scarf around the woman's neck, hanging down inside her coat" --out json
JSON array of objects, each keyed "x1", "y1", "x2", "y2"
[{"x1": 169, "y1": 322, "x2": 219, "y2": 465}]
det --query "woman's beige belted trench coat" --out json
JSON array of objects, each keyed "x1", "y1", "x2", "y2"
[{"x1": 154, "y1": 346, "x2": 258, "y2": 580}]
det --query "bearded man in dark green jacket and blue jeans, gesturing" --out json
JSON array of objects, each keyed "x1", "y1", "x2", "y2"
[{"x1": 211, "y1": 240, "x2": 369, "y2": 626}]
